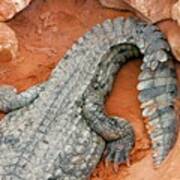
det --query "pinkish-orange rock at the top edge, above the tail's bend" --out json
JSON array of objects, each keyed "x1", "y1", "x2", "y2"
[{"x1": 100, "y1": 0, "x2": 177, "y2": 23}]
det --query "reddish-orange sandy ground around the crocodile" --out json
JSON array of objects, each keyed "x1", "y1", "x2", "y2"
[{"x1": 0, "y1": 0, "x2": 180, "y2": 180}]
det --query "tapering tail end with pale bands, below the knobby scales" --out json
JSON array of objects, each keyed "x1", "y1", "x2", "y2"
[{"x1": 137, "y1": 57, "x2": 177, "y2": 167}]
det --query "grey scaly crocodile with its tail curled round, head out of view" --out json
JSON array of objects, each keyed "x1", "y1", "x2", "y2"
[{"x1": 0, "y1": 17, "x2": 177, "y2": 180}]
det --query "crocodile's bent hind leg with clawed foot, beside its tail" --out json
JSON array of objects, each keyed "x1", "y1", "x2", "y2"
[{"x1": 83, "y1": 91, "x2": 134, "y2": 167}]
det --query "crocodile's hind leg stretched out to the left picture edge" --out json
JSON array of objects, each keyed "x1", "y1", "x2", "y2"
[{"x1": 0, "y1": 83, "x2": 45, "y2": 112}]
